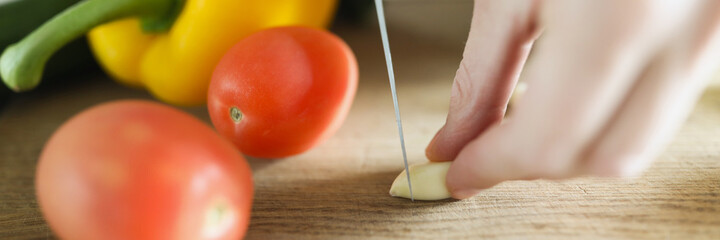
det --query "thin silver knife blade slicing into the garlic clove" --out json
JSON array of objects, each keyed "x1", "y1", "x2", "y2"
[{"x1": 375, "y1": 0, "x2": 415, "y2": 201}]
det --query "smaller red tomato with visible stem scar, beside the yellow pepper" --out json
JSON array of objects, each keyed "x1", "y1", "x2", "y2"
[{"x1": 208, "y1": 27, "x2": 358, "y2": 158}]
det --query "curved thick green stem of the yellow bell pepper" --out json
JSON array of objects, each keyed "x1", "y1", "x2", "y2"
[{"x1": 0, "y1": 0, "x2": 184, "y2": 92}]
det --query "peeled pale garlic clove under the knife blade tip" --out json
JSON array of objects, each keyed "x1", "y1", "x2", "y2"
[{"x1": 390, "y1": 162, "x2": 451, "y2": 200}]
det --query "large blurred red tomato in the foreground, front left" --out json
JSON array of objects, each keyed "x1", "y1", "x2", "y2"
[{"x1": 36, "y1": 101, "x2": 253, "y2": 240}]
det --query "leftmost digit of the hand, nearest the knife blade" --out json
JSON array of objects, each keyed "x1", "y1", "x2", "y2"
[{"x1": 425, "y1": 0, "x2": 538, "y2": 161}]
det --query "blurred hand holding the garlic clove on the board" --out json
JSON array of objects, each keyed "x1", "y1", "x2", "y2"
[{"x1": 426, "y1": 0, "x2": 720, "y2": 199}]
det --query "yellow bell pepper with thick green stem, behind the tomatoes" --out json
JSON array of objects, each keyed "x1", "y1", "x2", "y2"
[{"x1": 0, "y1": 0, "x2": 336, "y2": 105}]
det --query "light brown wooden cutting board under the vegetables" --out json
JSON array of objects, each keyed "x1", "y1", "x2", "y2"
[{"x1": 0, "y1": 22, "x2": 720, "y2": 239}]
